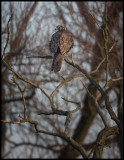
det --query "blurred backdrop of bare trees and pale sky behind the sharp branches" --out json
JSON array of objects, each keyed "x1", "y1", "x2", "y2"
[{"x1": 1, "y1": 1, "x2": 123, "y2": 158}]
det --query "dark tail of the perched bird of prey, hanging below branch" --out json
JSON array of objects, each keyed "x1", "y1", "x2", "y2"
[{"x1": 51, "y1": 53, "x2": 65, "y2": 73}]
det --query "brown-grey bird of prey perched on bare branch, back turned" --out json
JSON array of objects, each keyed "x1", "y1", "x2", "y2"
[{"x1": 49, "y1": 25, "x2": 73, "y2": 73}]
